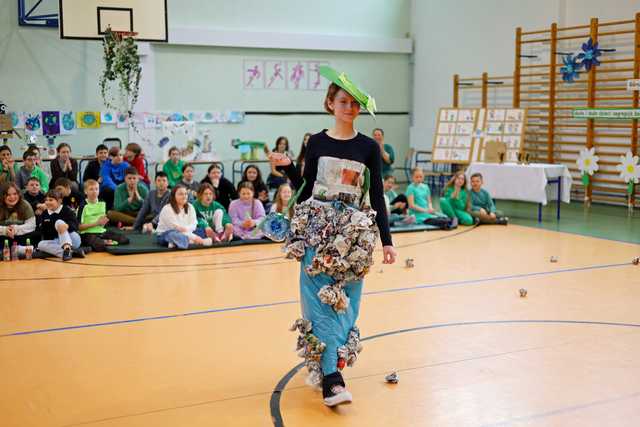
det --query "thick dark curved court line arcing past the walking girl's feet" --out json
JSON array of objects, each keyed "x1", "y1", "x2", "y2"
[{"x1": 269, "y1": 319, "x2": 640, "y2": 427}]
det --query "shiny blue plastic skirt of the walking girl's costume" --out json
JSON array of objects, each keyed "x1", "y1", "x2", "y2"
[{"x1": 300, "y1": 248, "x2": 362, "y2": 376}]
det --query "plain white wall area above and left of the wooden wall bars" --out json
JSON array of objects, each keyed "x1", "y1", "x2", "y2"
[{"x1": 410, "y1": 0, "x2": 640, "y2": 149}]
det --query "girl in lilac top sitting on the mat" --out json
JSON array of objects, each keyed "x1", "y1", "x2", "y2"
[{"x1": 229, "y1": 182, "x2": 265, "y2": 240}]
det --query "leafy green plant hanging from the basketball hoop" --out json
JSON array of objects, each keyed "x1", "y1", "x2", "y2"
[{"x1": 99, "y1": 28, "x2": 142, "y2": 123}]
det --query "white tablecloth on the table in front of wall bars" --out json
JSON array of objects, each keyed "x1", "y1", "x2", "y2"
[{"x1": 466, "y1": 162, "x2": 572, "y2": 205}]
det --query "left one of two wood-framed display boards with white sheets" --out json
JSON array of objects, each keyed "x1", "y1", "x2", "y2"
[{"x1": 432, "y1": 108, "x2": 484, "y2": 165}]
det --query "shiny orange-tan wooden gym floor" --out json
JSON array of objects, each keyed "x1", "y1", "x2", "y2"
[{"x1": 0, "y1": 225, "x2": 640, "y2": 427}]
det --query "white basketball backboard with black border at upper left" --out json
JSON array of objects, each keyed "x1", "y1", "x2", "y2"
[{"x1": 59, "y1": 0, "x2": 169, "y2": 42}]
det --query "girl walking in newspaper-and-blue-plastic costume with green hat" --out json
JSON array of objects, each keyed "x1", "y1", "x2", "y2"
[{"x1": 270, "y1": 66, "x2": 396, "y2": 406}]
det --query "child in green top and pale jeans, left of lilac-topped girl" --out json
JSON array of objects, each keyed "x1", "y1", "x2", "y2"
[{"x1": 193, "y1": 182, "x2": 233, "y2": 242}]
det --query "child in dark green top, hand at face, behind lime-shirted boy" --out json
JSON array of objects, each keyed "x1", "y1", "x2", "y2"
[{"x1": 107, "y1": 167, "x2": 149, "y2": 227}]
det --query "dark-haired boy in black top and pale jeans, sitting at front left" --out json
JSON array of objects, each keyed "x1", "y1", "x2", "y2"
[{"x1": 38, "y1": 190, "x2": 84, "y2": 261}]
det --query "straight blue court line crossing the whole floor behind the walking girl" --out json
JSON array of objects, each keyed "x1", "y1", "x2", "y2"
[{"x1": 0, "y1": 262, "x2": 631, "y2": 338}]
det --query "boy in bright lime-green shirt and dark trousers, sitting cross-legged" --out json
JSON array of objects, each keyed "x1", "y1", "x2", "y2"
[{"x1": 78, "y1": 179, "x2": 129, "y2": 252}]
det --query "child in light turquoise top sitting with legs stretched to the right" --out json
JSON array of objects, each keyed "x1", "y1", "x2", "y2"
[{"x1": 406, "y1": 168, "x2": 458, "y2": 229}]
